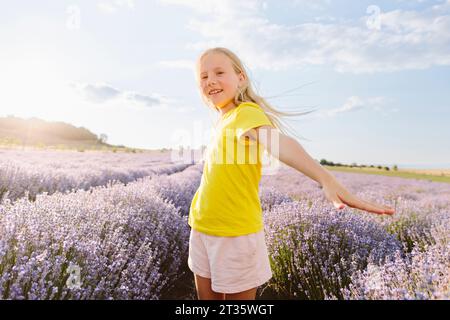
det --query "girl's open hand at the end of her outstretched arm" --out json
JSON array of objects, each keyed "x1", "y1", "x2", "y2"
[{"x1": 322, "y1": 178, "x2": 395, "y2": 215}]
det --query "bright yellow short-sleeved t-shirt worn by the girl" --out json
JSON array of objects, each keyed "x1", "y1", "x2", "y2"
[{"x1": 188, "y1": 102, "x2": 274, "y2": 237}]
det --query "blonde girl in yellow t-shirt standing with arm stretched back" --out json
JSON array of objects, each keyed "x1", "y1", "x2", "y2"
[{"x1": 188, "y1": 47, "x2": 394, "y2": 300}]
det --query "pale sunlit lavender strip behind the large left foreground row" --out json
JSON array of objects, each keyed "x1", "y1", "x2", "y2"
[{"x1": 0, "y1": 150, "x2": 189, "y2": 200}]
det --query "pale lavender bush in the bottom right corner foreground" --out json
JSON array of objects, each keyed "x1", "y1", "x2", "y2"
[{"x1": 342, "y1": 204, "x2": 450, "y2": 300}]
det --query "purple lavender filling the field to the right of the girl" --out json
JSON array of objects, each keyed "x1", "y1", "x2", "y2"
[{"x1": 261, "y1": 169, "x2": 450, "y2": 299}]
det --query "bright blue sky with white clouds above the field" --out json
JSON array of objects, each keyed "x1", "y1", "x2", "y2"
[{"x1": 0, "y1": 0, "x2": 450, "y2": 168}]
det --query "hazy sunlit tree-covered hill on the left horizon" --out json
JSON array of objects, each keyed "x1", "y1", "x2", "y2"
[{"x1": 0, "y1": 116, "x2": 111, "y2": 147}]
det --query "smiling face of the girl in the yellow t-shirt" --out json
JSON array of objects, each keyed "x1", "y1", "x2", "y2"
[{"x1": 197, "y1": 53, "x2": 245, "y2": 108}]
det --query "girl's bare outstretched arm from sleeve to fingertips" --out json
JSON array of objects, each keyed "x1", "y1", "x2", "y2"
[{"x1": 244, "y1": 126, "x2": 395, "y2": 214}]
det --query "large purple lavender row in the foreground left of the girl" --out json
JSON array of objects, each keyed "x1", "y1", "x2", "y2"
[{"x1": 0, "y1": 166, "x2": 201, "y2": 299}]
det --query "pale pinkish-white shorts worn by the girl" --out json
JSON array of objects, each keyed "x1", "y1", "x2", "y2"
[{"x1": 188, "y1": 229, "x2": 272, "y2": 293}]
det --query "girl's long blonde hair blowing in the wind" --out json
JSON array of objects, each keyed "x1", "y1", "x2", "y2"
[{"x1": 197, "y1": 47, "x2": 315, "y2": 141}]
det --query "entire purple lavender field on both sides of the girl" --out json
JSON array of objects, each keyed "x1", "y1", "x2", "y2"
[{"x1": 0, "y1": 150, "x2": 450, "y2": 299}]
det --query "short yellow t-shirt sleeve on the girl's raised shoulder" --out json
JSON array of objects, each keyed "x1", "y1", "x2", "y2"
[{"x1": 235, "y1": 104, "x2": 274, "y2": 140}]
